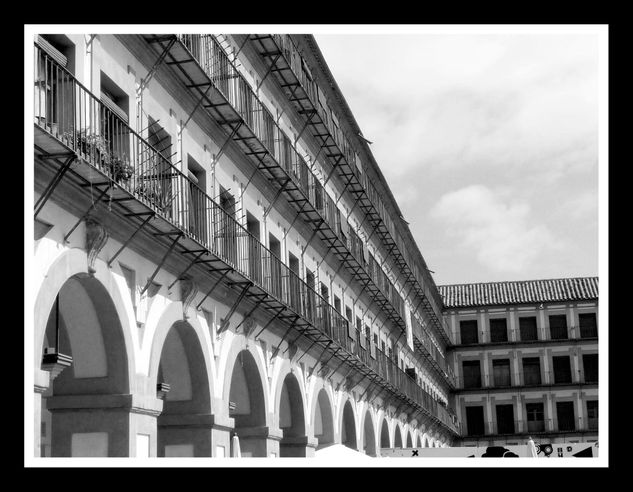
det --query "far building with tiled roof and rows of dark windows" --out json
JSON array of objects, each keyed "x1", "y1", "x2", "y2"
[{"x1": 439, "y1": 277, "x2": 598, "y2": 446}]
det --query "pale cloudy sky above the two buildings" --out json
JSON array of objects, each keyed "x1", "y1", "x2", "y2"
[{"x1": 315, "y1": 32, "x2": 600, "y2": 285}]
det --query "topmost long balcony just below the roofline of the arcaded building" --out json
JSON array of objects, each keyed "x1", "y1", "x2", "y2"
[{"x1": 250, "y1": 34, "x2": 451, "y2": 345}]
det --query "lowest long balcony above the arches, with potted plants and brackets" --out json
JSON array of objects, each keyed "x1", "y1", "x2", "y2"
[{"x1": 34, "y1": 40, "x2": 459, "y2": 434}]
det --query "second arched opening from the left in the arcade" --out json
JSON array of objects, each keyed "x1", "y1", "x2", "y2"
[{"x1": 157, "y1": 321, "x2": 212, "y2": 457}]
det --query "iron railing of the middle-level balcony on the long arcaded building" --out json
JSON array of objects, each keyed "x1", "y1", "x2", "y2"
[{"x1": 172, "y1": 34, "x2": 453, "y2": 385}]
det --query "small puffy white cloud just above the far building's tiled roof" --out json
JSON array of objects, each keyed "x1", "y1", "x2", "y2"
[{"x1": 430, "y1": 185, "x2": 563, "y2": 274}]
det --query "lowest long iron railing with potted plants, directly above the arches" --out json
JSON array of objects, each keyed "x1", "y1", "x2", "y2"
[{"x1": 34, "y1": 44, "x2": 459, "y2": 434}]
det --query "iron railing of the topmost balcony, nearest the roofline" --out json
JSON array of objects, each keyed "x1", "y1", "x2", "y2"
[{"x1": 247, "y1": 34, "x2": 451, "y2": 344}]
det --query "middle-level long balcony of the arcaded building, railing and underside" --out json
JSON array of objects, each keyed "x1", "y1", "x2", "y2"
[{"x1": 138, "y1": 34, "x2": 452, "y2": 392}]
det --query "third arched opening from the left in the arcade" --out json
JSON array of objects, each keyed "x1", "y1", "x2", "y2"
[{"x1": 227, "y1": 350, "x2": 267, "y2": 457}]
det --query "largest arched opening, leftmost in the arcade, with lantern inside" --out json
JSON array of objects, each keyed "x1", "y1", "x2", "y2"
[{"x1": 36, "y1": 274, "x2": 130, "y2": 457}]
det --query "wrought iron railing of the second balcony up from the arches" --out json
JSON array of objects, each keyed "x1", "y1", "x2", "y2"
[{"x1": 150, "y1": 34, "x2": 454, "y2": 387}]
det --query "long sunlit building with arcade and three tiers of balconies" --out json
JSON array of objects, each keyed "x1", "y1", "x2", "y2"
[{"x1": 31, "y1": 34, "x2": 460, "y2": 457}]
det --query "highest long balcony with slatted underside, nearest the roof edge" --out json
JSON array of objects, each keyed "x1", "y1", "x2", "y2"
[{"x1": 249, "y1": 34, "x2": 451, "y2": 345}]
